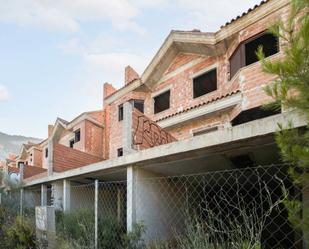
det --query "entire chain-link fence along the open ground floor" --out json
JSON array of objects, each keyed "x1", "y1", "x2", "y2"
[{"x1": 0, "y1": 165, "x2": 309, "y2": 249}]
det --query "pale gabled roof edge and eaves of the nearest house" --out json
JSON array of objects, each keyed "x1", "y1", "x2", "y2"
[{"x1": 105, "y1": 0, "x2": 289, "y2": 103}]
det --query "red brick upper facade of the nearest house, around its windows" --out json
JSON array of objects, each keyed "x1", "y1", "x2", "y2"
[{"x1": 104, "y1": 3, "x2": 289, "y2": 152}]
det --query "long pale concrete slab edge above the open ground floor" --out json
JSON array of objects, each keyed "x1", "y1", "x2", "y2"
[{"x1": 25, "y1": 111, "x2": 307, "y2": 186}]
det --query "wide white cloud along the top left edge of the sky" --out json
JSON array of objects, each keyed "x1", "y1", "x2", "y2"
[{"x1": 0, "y1": 0, "x2": 141, "y2": 32}]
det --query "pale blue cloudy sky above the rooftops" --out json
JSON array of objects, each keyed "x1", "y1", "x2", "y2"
[{"x1": 0, "y1": 0, "x2": 261, "y2": 138}]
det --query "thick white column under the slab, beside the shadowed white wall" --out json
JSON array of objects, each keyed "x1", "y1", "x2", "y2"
[{"x1": 127, "y1": 166, "x2": 136, "y2": 232}]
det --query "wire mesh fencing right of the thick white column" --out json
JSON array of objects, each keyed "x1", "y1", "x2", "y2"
[{"x1": 135, "y1": 166, "x2": 309, "y2": 249}]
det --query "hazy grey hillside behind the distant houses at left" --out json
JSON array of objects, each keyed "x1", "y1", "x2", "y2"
[{"x1": 0, "y1": 132, "x2": 41, "y2": 160}]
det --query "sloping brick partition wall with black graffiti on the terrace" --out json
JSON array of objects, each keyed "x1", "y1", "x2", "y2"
[{"x1": 132, "y1": 109, "x2": 176, "y2": 150}]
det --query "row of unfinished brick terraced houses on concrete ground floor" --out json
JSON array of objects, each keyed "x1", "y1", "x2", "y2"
[{"x1": 3, "y1": 0, "x2": 309, "y2": 248}]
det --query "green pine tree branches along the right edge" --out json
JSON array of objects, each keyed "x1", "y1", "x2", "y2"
[{"x1": 257, "y1": 0, "x2": 309, "y2": 243}]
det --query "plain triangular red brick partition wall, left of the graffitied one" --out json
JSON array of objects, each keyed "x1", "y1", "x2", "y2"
[{"x1": 53, "y1": 144, "x2": 102, "y2": 172}]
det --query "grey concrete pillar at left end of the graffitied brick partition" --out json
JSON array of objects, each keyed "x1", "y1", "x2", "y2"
[{"x1": 122, "y1": 102, "x2": 134, "y2": 155}]
